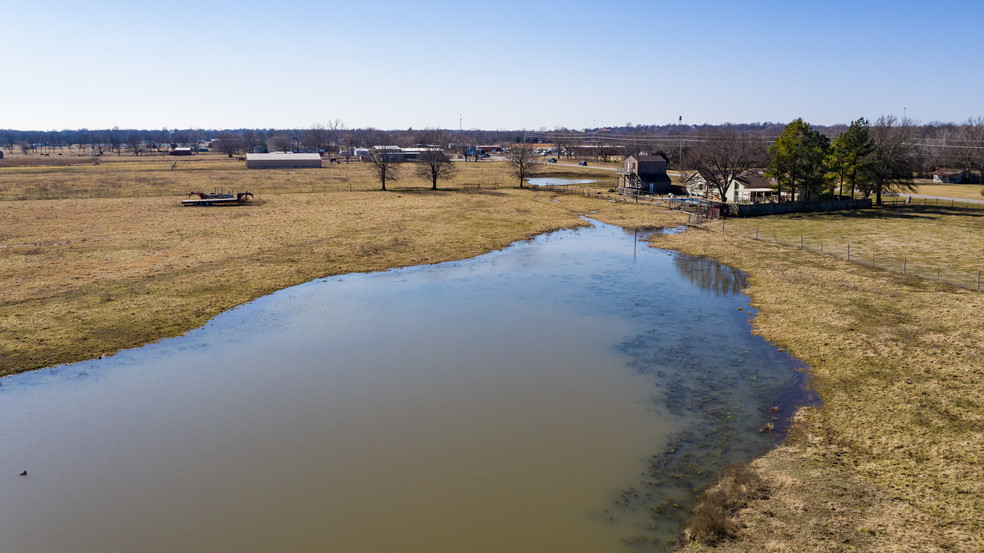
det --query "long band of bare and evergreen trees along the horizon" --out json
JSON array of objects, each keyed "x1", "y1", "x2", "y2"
[{"x1": 0, "y1": 116, "x2": 984, "y2": 202}]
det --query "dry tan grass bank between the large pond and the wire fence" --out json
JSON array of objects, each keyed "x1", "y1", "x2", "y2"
[{"x1": 654, "y1": 224, "x2": 984, "y2": 551}]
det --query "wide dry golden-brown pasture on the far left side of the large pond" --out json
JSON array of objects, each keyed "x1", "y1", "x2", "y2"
[{"x1": 0, "y1": 159, "x2": 679, "y2": 374}]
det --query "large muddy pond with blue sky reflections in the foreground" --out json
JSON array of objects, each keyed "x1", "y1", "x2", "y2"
[{"x1": 0, "y1": 219, "x2": 803, "y2": 553}]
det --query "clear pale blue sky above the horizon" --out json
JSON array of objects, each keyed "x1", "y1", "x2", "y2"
[{"x1": 0, "y1": 0, "x2": 984, "y2": 130}]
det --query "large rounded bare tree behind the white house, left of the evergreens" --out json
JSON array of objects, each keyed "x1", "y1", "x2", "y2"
[{"x1": 688, "y1": 130, "x2": 765, "y2": 201}]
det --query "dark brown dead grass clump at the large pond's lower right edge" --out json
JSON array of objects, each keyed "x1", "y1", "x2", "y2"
[{"x1": 684, "y1": 465, "x2": 765, "y2": 545}]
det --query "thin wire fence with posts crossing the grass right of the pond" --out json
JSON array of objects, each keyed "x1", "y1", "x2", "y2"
[{"x1": 704, "y1": 219, "x2": 984, "y2": 291}]
